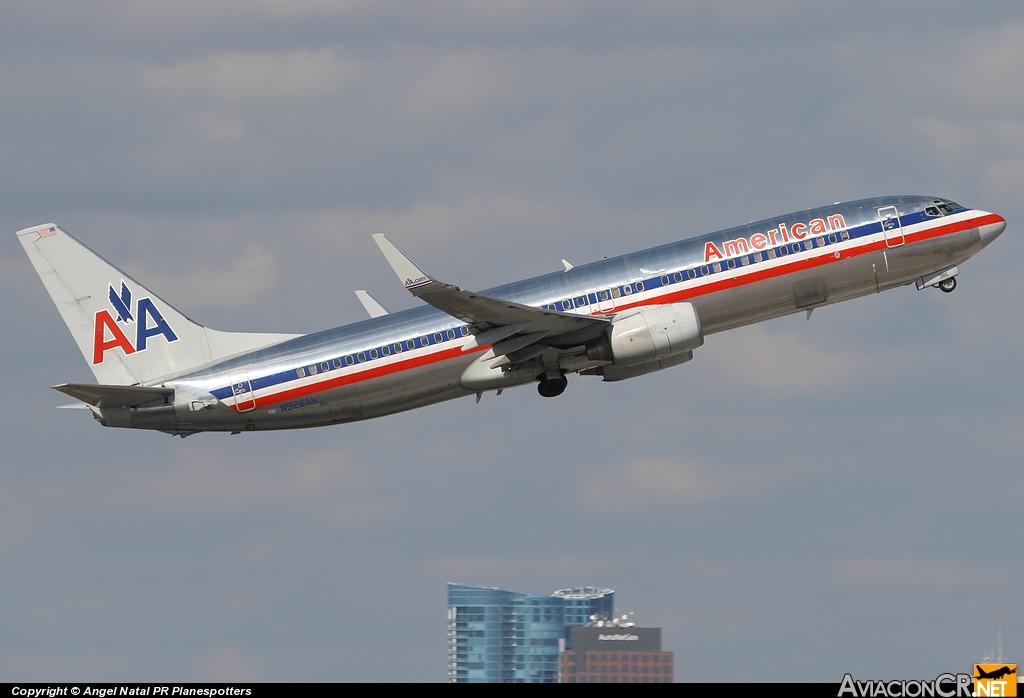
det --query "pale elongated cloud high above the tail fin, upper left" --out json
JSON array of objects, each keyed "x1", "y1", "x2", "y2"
[{"x1": 140, "y1": 48, "x2": 358, "y2": 102}]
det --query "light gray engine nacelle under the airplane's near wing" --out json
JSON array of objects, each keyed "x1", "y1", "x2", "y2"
[{"x1": 587, "y1": 303, "x2": 703, "y2": 366}]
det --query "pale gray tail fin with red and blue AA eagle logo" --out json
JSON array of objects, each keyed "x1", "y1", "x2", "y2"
[{"x1": 17, "y1": 223, "x2": 299, "y2": 386}]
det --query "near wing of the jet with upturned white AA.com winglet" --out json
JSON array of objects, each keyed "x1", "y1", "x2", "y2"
[{"x1": 374, "y1": 233, "x2": 610, "y2": 339}]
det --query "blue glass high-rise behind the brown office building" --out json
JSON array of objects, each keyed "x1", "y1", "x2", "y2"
[{"x1": 447, "y1": 583, "x2": 614, "y2": 683}]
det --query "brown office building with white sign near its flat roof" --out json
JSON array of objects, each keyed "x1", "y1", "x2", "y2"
[{"x1": 561, "y1": 624, "x2": 675, "y2": 684}]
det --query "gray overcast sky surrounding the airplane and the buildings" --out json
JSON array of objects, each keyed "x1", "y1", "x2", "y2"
[{"x1": 0, "y1": 0, "x2": 1024, "y2": 682}]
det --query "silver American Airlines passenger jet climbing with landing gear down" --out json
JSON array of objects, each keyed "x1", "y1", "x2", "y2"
[{"x1": 17, "y1": 197, "x2": 1006, "y2": 437}]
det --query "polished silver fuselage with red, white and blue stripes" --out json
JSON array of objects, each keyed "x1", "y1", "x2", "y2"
[{"x1": 110, "y1": 197, "x2": 1005, "y2": 434}]
